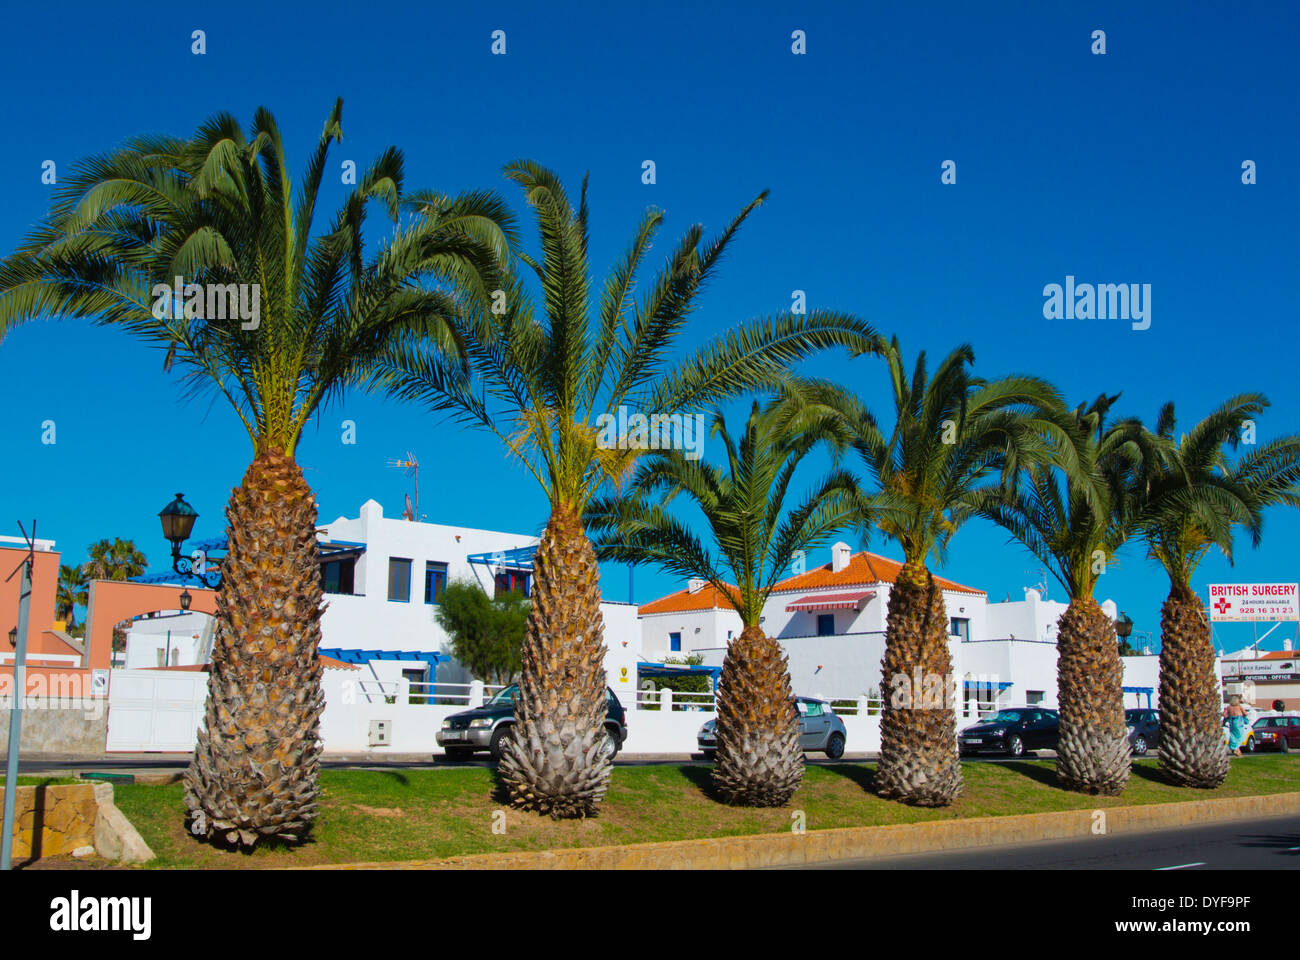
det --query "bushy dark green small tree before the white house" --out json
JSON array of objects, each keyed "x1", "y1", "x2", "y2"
[{"x1": 436, "y1": 580, "x2": 529, "y2": 684}]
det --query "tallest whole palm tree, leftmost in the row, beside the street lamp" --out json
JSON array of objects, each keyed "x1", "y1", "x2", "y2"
[{"x1": 0, "y1": 100, "x2": 511, "y2": 847}]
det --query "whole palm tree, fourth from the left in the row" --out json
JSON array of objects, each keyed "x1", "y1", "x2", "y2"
[{"x1": 850, "y1": 337, "x2": 1060, "y2": 807}]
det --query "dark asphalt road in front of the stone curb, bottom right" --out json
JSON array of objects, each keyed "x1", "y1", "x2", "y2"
[{"x1": 787, "y1": 816, "x2": 1300, "y2": 870}]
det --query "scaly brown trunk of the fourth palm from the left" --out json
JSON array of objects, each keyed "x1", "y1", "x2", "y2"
[{"x1": 876, "y1": 561, "x2": 962, "y2": 807}]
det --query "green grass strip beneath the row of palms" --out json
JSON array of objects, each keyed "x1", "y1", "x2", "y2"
[{"x1": 114, "y1": 756, "x2": 1300, "y2": 868}]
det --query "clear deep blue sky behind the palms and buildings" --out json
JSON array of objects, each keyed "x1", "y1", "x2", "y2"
[{"x1": 0, "y1": 3, "x2": 1300, "y2": 648}]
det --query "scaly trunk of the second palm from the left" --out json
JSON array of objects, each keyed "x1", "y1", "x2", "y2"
[{"x1": 499, "y1": 503, "x2": 614, "y2": 818}]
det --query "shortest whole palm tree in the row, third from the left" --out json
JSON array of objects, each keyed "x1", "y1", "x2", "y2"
[{"x1": 586, "y1": 392, "x2": 859, "y2": 807}]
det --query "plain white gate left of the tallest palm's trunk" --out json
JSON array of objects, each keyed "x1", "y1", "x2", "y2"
[{"x1": 105, "y1": 670, "x2": 208, "y2": 753}]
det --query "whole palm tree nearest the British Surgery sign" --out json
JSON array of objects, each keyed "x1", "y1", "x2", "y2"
[{"x1": 1139, "y1": 393, "x2": 1300, "y2": 788}]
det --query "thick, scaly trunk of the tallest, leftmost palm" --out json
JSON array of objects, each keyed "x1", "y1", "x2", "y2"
[{"x1": 185, "y1": 449, "x2": 325, "y2": 847}]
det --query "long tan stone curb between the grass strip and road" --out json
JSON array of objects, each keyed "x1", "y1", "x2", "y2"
[{"x1": 308, "y1": 792, "x2": 1300, "y2": 870}]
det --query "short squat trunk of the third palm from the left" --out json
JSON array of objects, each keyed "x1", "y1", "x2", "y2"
[{"x1": 714, "y1": 626, "x2": 803, "y2": 807}]
